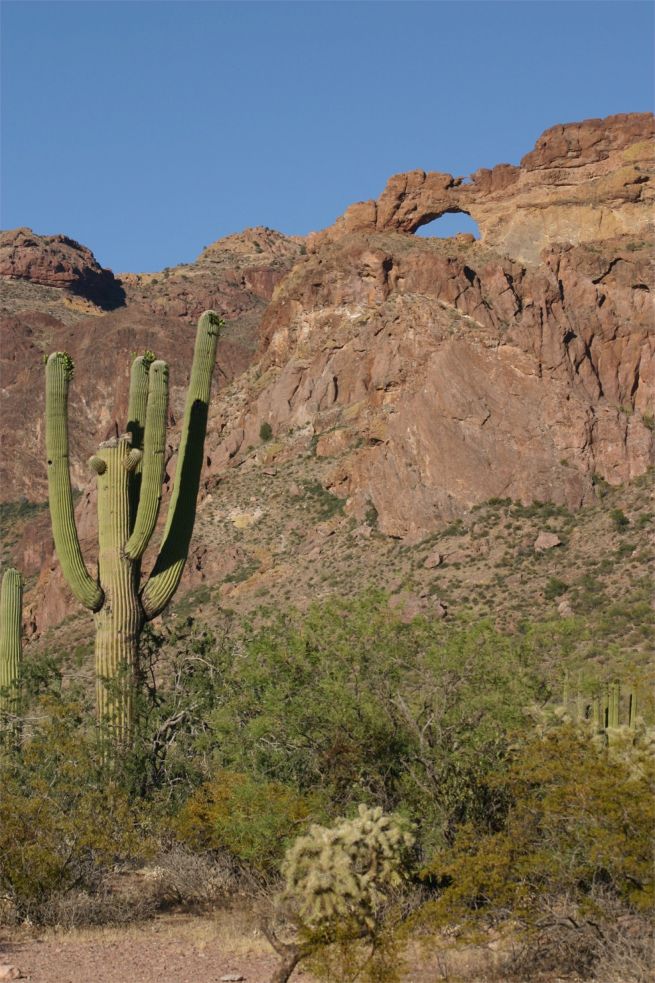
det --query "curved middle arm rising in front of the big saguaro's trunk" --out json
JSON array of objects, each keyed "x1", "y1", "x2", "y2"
[{"x1": 125, "y1": 361, "x2": 168, "y2": 560}]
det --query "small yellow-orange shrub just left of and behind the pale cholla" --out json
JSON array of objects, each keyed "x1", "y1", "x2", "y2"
[{"x1": 175, "y1": 771, "x2": 317, "y2": 874}]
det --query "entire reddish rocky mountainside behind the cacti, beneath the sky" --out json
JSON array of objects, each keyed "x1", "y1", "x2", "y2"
[{"x1": 0, "y1": 114, "x2": 655, "y2": 635}]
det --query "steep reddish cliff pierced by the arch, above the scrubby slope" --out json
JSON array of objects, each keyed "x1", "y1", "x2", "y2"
[{"x1": 217, "y1": 114, "x2": 655, "y2": 540}]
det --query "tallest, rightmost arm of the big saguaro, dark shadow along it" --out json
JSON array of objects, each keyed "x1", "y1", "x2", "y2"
[{"x1": 141, "y1": 311, "x2": 223, "y2": 619}]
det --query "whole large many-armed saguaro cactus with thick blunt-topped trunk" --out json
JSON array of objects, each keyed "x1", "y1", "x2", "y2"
[{"x1": 46, "y1": 311, "x2": 223, "y2": 743}]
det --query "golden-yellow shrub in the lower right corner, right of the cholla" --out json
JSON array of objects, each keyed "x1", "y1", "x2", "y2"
[{"x1": 423, "y1": 725, "x2": 655, "y2": 978}]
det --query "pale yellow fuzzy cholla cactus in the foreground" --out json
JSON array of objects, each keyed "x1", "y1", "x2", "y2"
[{"x1": 282, "y1": 805, "x2": 414, "y2": 935}]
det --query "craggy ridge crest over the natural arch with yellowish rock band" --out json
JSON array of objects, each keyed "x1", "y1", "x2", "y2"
[{"x1": 312, "y1": 113, "x2": 655, "y2": 264}]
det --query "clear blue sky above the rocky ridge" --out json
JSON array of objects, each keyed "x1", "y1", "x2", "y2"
[{"x1": 1, "y1": 0, "x2": 654, "y2": 272}]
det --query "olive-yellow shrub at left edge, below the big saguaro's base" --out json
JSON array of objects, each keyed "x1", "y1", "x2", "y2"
[{"x1": 0, "y1": 698, "x2": 155, "y2": 921}]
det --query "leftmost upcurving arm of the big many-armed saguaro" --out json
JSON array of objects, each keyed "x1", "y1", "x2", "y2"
[{"x1": 45, "y1": 352, "x2": 104, "y2": 611}]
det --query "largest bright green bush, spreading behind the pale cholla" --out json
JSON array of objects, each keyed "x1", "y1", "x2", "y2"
[{"x1": 208, "y1": 596, "x2": 535, "y2": 856}]
